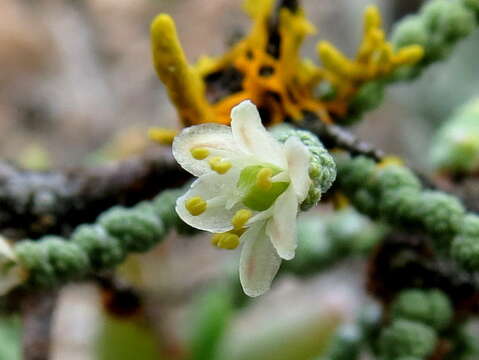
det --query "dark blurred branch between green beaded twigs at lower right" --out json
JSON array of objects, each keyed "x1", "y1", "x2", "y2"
[{"x1": 368, "y1": 231, "x2": 479, "y2": 314}]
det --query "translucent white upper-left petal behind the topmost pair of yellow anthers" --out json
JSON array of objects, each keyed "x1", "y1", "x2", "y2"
[{"x1": 172, "y1": 124, "x2": 238, "y2": 176}]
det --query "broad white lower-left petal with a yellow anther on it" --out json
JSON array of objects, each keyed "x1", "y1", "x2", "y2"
[{"x1": 176, "y1": 171, "x2": 242, "y2": 233}]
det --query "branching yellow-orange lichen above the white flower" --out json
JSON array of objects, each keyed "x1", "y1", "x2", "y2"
[{"x1": 152, "y1": 0, "x2": 423, "y2": 131}]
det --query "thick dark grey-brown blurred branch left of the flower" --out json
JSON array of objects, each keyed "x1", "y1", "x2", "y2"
[{"x1": 0, "y1": 149, "x2": 189, "y2": 238}]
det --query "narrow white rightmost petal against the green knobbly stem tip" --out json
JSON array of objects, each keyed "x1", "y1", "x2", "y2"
[{"x1": 284, "y1": 136, "x2": 311, "y2": 203}]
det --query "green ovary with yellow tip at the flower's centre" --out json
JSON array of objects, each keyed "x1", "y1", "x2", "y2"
[{"x1": 236, "y1": 165, "x2": 289, "y2": 211}]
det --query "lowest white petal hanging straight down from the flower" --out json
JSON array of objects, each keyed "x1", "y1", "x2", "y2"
[{"x1": 239, "y1": 222, "x2": 281, "y2": 297}]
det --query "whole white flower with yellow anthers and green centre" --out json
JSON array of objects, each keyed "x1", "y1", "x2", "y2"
[{"x1": 173, "y1": 101, "x2": 311, "y2": 296}]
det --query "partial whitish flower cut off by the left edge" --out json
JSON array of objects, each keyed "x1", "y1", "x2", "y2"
[{"x1": 0, "y1": 236, "x2": 25, "y2": 296}]
